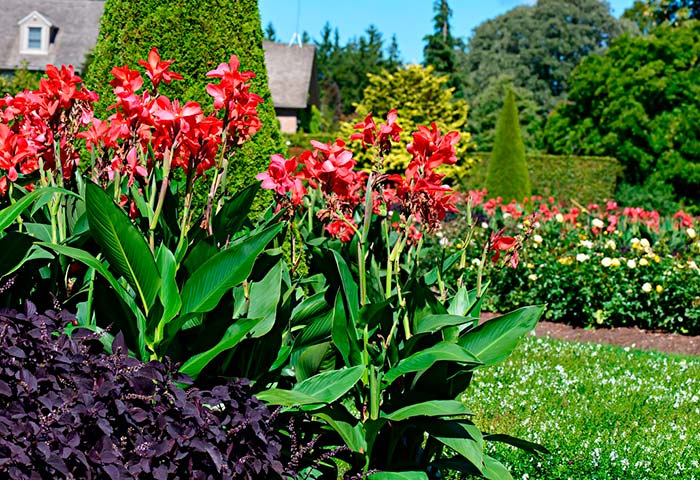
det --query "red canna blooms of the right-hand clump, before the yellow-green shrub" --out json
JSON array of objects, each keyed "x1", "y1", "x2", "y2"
[{"x1": 256, "y1": 110, "x2": 460, "y2": 242}]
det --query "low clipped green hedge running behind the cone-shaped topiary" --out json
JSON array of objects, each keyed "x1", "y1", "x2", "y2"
[{"x1": 462, "y1": 153, "x2": 623, "y2": 205}]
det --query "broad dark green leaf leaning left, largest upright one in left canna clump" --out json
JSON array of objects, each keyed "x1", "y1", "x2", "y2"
[{"x1": 85, "y1": 183, "x2": 160, "y2": 314}]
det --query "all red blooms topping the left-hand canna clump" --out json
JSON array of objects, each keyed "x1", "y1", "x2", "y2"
[{"x1": 0, "y1": 47, "x2": 262, "y2": 205}]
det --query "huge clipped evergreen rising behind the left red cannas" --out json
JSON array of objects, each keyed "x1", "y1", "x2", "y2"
[{"x1": 85, "y1": 0, "x2": 282, "y2": 196}]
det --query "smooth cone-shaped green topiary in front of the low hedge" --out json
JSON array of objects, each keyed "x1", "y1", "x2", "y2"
[{"x1": 486, "y1": 88, "x2": 531, "y2": 203}]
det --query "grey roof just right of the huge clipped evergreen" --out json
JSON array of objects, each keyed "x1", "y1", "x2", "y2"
[{"x1": 264, "y1": 40, "x2": 316, "y2": 108}]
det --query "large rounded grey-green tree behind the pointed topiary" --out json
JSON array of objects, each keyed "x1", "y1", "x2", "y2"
[{"x1": 459, "y1": 0, "x2": 634, "y2": 147}]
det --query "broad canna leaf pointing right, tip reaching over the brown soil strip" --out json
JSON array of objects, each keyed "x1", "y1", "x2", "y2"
[{"x1": 458, "y1": 305, "x2": 544, "y2": 365}]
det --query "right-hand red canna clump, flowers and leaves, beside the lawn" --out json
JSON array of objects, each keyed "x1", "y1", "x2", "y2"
[{"x1": 253, "y1": 111, "x2": 546, "y2": 479}]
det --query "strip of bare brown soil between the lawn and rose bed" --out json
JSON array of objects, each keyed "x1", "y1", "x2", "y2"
[{"x1": 482, "y1": 313, "x2": 700, "y2": 356}]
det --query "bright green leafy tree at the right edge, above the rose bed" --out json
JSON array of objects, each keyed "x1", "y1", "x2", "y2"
[{"x1": 544, "y1": 21, "x2": 700, "y2": 201}]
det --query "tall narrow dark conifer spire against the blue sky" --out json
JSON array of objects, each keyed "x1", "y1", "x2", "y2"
[{"x1": 423, "y1": 0, "x2": 462, "y2": 96}]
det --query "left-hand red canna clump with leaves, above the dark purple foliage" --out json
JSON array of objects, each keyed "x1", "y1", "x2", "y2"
[{"x1": 0, "y1": 48, "x2": 285, "y2": 377}]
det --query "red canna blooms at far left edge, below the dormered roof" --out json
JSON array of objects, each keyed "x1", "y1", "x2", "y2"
[{"x1": 0, "y1": 65, "x2": 98, "y2": 196}]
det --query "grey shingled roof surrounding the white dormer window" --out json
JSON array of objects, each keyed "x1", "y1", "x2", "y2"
[{"x1": 0, "y1": 0, "x2": 104, "y2": 70}]
